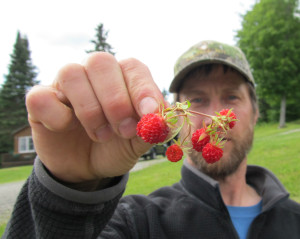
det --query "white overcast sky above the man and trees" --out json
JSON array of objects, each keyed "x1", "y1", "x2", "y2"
[{"x1": 0, "y1": 0, "x2": 256, "y2": 90}]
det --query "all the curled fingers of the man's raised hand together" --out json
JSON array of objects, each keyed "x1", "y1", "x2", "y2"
[{"x1": 27, "y1": 53, "x2": 163, "y2": 142}]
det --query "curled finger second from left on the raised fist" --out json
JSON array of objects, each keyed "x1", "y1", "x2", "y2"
[{"x1": 54, "y1": 64, "x2": 113, "y2": 141}]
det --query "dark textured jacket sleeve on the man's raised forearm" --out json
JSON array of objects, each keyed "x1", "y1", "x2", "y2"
[{"x1": 2, "y1": 158, "x2": 128, "y2": 239}]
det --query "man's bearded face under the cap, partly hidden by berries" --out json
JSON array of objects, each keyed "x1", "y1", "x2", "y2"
[{"x1": 179, "y1": 65, "x2": 258, "y2": 180}]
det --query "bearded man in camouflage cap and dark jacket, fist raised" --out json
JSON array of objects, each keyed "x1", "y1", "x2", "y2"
[{"x1": 4, "y1": 41, "x2": 300, "y2": 239}]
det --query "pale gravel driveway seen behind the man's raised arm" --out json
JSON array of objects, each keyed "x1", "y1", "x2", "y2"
[{"x1": 0, "y1": 159, "x2": 165, "y2": 225}]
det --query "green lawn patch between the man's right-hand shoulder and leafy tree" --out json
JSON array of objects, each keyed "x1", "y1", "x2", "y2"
[{"x1": 248, "y1": 121, "x2": 300, "y2": 202}]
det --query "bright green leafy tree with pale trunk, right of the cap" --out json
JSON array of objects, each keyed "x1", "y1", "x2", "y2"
[{"x1": 237, "y1": 0, "x2": 300, "y2": 127}]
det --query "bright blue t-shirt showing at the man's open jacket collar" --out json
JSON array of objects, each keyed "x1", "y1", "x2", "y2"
[{"x1": 227, "y1": 201, "x2": 262, "y2": 239}]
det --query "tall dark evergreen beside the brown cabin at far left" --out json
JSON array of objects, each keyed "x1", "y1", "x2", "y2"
[{"x1": 0, "y1": 32, "x2": 38, "y2": 153}]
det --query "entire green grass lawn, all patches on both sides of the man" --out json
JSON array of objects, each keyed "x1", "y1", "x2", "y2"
[{"x1": 0, "y1": 121, "x2": 300, "y2": 235}]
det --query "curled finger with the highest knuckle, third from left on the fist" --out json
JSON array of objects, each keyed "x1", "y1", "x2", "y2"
[{"x1": 85, "y1": 53, "x2": 137, "y2": 138}]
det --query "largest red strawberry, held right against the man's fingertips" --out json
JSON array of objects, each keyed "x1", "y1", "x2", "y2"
[{"x1": 136, "y1": 113, "x2": 170, "y2": 144}]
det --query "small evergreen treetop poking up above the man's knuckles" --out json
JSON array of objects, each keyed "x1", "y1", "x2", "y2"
[{"x1": 86, "y1": 23, "x2": 115, "y2": 55}]
